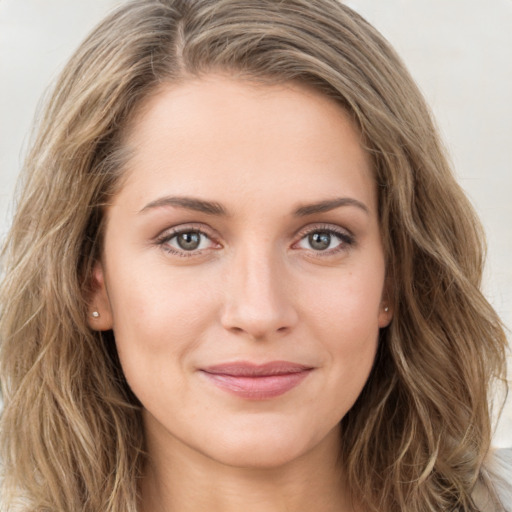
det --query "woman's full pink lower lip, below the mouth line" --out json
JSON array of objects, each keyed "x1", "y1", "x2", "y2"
[{"x1": 202, "y1": 370, "x2": 311, "y2": 400}]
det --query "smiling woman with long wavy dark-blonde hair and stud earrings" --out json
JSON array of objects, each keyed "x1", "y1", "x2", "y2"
[{"x1": 1, "y1": 0, "x2": 507, "y2": 512}]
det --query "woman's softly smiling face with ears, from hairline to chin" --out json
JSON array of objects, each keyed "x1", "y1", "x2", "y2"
[{"x1": 91, "y1": 76, "x2": 391, "y2": 467}]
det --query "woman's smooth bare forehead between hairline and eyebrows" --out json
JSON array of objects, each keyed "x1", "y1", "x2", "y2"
[{"x1": 114, "y1": 76, "x2": 375, "y2": 213}]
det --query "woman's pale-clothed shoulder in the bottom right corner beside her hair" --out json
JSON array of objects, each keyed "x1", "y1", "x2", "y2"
[{"x1": 473, "y1": 448, "x2": 512, "y2": 512}]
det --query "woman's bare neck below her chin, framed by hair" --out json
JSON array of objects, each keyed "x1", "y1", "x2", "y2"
[{"x1": 141, "y1": 420, "x2": 356, "y2": 512}]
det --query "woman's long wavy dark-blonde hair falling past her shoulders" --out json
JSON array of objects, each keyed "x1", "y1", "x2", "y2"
[{"x1": 0, "y1": 0, "x2": 506, "y2": 512}]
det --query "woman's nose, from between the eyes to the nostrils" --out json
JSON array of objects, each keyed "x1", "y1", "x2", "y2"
[{"x1": 221, "y1": 248, "x2": 298, "y2": 340}]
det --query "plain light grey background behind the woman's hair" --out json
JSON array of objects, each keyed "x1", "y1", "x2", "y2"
[{"x1": 0, "y1": 0, "x2": 512, "y2": 446}]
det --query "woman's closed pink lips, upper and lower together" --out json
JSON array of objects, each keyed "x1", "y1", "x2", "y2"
[{"x1": 201, "y1": 361, "x2": 313, "y2": 400}]
